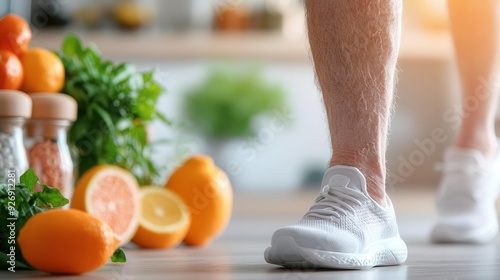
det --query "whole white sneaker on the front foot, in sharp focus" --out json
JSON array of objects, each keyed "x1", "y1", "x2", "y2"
[{"x1": 264, "y1": 165, "x2": 408, "y2": 269}]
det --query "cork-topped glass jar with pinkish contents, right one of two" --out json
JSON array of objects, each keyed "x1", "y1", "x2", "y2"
[{"x1": 27, "y1": 93, "x2": 77, "y2": 202}]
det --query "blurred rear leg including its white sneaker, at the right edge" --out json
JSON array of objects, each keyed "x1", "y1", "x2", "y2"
[{"x1": 431, "y1": 0, "x2": 500, "y2": 243}]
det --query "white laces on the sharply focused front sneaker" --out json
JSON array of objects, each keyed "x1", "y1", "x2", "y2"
[{"x1": 305, "y1": 185, "x2": 366, "y2": 220}]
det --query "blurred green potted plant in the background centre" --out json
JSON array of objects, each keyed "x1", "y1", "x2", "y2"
[{"x1": 185, "y1": 67, "x2": 285, "y2": 167}]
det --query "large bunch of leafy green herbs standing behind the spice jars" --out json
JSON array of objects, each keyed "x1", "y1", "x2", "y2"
[{"x1": 58, "y1": 34, "x2": 168, "y2": 185}]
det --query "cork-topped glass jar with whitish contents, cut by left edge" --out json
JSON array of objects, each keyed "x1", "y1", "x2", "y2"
[{"x1": 0, "y1": 90, "x2": 31, "y2": 182}]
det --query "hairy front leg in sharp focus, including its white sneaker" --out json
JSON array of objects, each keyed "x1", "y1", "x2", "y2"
[{"x1": 264, "y1": 0, "x2": 408, "y2": 269}]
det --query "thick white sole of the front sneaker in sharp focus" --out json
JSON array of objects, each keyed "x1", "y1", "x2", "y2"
[{"x1": 264, "y1": 236, "x2": 408, "y2": 269}]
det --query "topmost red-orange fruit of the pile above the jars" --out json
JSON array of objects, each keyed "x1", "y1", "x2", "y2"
[{"x1": 0, "y1": 14, "x2": 31, "y2": 55}]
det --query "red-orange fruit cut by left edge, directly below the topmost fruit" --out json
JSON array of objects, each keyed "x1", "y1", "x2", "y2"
[{"x1": 0, "y1": 50, "x2": 24, "y2": 89}]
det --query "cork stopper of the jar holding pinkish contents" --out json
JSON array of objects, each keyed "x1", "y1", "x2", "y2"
[{"x1": 27, "y1": 93, "x2": 77, "y2": 139}]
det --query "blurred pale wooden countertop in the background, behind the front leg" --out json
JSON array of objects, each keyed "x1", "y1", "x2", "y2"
[{"x1": 31, "y1": 28, "x2": 453, "y2": 63}]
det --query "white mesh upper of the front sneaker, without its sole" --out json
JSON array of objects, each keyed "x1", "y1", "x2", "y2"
[{"x1": 272, "y1": 166, "x2": 399, "y2": 253}]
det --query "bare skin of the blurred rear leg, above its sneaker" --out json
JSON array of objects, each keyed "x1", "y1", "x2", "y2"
[{"x1": 448, "y1": 0, "x2": 500, "y2": 158}]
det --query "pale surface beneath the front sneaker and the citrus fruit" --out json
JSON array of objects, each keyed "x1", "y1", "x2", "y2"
[{"x1": 0, "y1": 186, "x2": 500, "y2": 280}]
